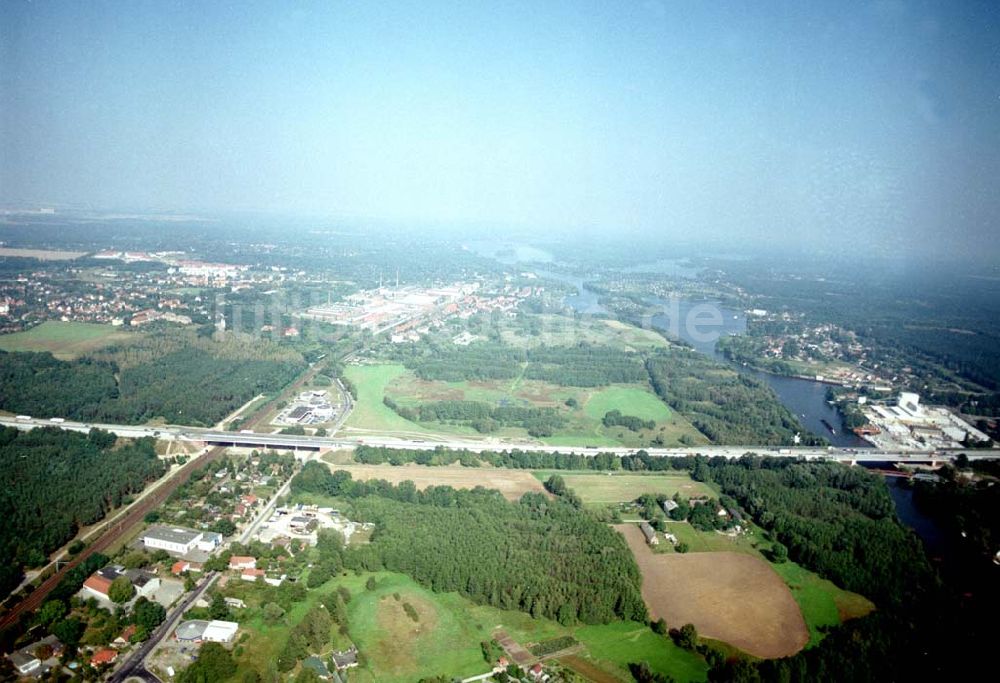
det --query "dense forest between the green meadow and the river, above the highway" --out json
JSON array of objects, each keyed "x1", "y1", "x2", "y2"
[{"x1": 646, "y1": 347, "x2": 820, "y2": 445}]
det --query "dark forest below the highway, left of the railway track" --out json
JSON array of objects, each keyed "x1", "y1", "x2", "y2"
[{"x1": 0, "y1": 427, "x2": 165, "y2": 594}]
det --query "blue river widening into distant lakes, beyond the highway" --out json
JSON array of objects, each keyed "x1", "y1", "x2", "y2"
[{"x1": 467, "y1": 241, "x2": 870, "y2": 448}]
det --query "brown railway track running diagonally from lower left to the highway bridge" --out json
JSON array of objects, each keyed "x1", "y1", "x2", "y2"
[{"x1": 0, "y1": 448, "x2": 225, "y2": 630}]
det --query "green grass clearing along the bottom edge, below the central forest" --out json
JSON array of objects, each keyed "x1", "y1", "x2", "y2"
[{"x1": 225, "y1": 572, "x2": 707, "y2": 683}]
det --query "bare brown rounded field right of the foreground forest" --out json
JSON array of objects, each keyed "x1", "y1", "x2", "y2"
[{"x1": 616, "y1": 524, "x2": 810, "y2": 657}]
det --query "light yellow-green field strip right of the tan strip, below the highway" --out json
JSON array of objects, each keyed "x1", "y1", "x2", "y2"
[{"x1": 534, "y1": 470, "x2": 717, "y2": 506}]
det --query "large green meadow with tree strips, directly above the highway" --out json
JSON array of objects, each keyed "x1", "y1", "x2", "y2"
[{"x1": 345, "y1": 363, "x2": 708, "y2": 447}]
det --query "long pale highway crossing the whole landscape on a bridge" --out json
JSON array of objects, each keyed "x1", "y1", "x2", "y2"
[{"x1": 0, "y1": 411, "x2": 1000, "y2": 462}]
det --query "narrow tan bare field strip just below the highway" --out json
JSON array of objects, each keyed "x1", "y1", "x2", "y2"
[{"x1": 318, "y1": 463, "x2": 545, "y2": 500}]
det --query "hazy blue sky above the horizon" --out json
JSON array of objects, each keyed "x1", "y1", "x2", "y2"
[{"x1": 0, "y1": 0, "x2": 1000, "y2": 256}]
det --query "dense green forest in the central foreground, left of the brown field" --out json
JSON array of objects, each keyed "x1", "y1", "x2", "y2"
[{"x1": 292, "y1": 462, "x2": 647, "y2": 624}]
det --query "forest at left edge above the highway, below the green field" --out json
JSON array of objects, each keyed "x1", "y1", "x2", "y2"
[{"x1": 0, "y1": 334, "x2": 305, "y2": 426}]
